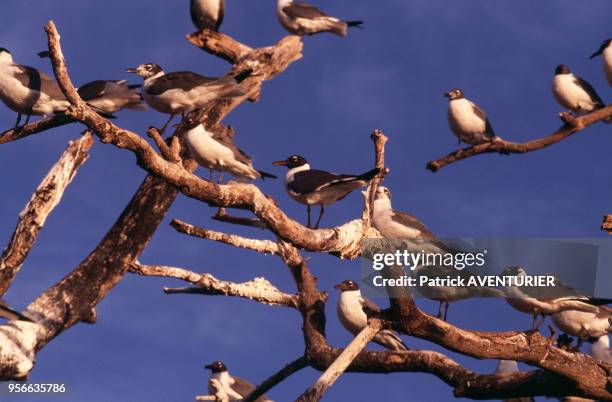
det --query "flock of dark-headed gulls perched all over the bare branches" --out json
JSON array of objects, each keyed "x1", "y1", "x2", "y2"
[{"x1": 0, "y1": 0, "x2": 612, "y2": 401}]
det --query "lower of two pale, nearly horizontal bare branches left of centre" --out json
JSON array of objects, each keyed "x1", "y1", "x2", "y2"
[{"x1": 130, "y1": 262, "x2": 298, "y2": 308}]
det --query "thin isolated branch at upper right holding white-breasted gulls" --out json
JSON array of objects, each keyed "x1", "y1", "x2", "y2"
[{"x1": 427, "y1": 105, "x2": 612, "y2": 172}]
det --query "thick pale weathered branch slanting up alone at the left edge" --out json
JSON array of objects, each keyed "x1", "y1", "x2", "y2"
[{"x1": 0, "y1": 132, "x2": 93, "y2": 296}]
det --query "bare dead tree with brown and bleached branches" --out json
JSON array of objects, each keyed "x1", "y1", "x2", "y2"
[{"x1": 0, "y1": 22, "x2": 612, "y2": 401}]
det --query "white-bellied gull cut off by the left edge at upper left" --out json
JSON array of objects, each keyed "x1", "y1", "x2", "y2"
[{"x1": 0, "y1": 48, "x2": 70, "y2": 127}]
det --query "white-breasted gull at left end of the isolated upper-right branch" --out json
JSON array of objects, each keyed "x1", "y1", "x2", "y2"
[{"x1": 444, "y1": 89, "x2": 499, "y2": 146}]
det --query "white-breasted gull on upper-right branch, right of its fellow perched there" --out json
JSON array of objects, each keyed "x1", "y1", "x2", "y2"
[{"x1": 552, "y1": 64, "x2": 612, "y2": 121}]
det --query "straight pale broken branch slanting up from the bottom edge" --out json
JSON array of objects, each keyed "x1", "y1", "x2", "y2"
[{"x1": 297, "y1": 319, "x2": 383, "y2": 402}]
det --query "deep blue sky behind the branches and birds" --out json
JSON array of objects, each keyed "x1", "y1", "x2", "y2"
[{"x1": 0, "y1": 0, "x2": 612, "y2": 401}]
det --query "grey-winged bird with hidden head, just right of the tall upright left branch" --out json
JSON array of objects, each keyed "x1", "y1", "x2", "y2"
[{"x1": 38, "y1": 50, "x2": 146, "y2": 117}]
